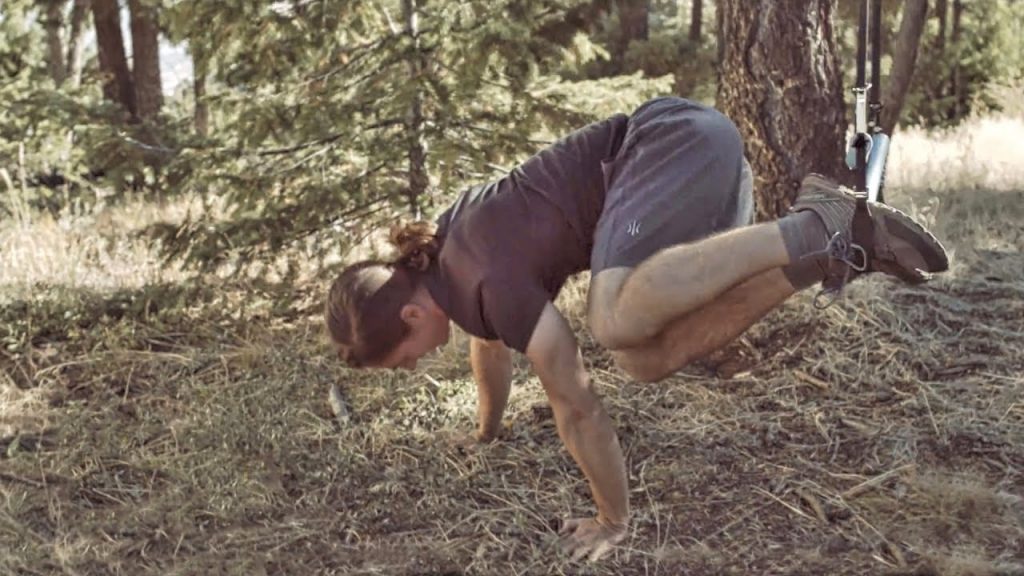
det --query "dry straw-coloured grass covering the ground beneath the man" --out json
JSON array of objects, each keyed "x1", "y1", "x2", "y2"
[{"x1": 6, "y1": 116, "x2": 1024, "y2": 576}]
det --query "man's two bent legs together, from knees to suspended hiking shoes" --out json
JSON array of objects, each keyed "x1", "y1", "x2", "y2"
[{"x1": 588, "y1": 175, "x2": 948, "y2": 379}]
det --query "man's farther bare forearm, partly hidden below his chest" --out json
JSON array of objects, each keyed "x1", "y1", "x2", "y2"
[{"x1": 469, "y1": 337, "x2": 512, "y2": 442}]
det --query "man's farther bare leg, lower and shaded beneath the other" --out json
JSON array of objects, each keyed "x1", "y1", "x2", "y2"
[{"x1": 611, "y1": 269, "x2": 797, "y2": 381}]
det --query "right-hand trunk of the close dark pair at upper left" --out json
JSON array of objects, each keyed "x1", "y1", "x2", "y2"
[{"x1": 128, "y1": 0, "x2": 164, "y2": 120}]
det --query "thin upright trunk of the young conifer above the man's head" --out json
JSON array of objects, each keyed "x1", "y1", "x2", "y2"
[{"x1": 401, "y1": 0, "x2": 430, "y2": 219}]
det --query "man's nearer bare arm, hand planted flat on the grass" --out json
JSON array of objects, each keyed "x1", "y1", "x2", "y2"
[{"x1": 526, "y1": 302, "x2": 630, "y2": 560}]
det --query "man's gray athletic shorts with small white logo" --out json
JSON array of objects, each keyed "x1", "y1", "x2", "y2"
[{"x1": 591, "y1": 97, "x2": 754, "y2": 274}]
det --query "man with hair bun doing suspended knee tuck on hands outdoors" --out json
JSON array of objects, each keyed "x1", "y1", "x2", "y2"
[{"x1": 326, "y1": 97, "x2": 948, "y2": 559}]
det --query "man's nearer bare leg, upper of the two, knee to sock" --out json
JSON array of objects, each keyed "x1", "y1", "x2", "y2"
[{"x1": 588, "y1": 218, "x2": 792, "y2": 349}]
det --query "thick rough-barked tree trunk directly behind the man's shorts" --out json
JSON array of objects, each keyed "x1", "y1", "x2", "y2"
[{"x1": 717, "y1": 0, "x2": 848, "y2": 219}]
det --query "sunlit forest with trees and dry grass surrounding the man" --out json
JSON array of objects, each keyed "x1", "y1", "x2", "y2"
[{"x1": 0, "y1": 0, "x2": 1024, "y2": 575}]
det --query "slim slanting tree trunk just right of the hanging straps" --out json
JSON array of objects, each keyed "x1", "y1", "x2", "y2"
[{"x1": 882, "y1": 0, "x2": 928, "y2": 134}]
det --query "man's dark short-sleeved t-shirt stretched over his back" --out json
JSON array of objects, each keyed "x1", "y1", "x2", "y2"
[{"x1": 426, "y1": 114, "x2": 628, "y2": 352}]
